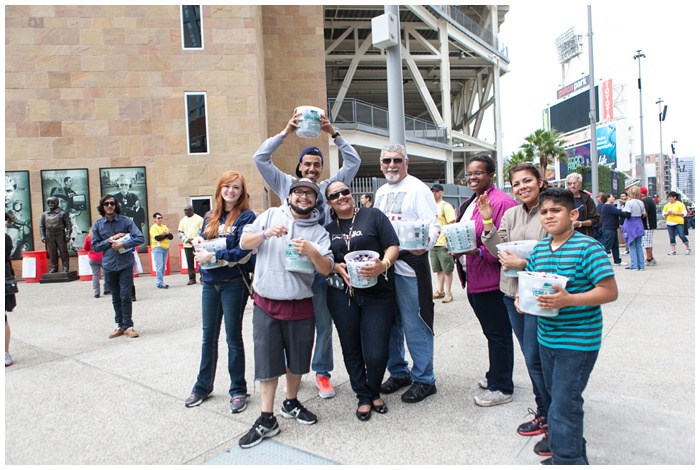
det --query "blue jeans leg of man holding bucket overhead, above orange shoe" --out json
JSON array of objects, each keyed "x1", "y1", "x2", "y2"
[{"x1": 311, "y1": 273, "x2": 333, "y2": 377}]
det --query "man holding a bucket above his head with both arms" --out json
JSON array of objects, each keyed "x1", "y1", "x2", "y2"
[{"x1": 253, "y1": 109, "x2": 360, "y2": 398}]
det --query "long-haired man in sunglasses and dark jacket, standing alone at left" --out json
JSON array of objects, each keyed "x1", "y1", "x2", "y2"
[{"x1": 92, "y1": 194, "x2": 144, "y2": 339}]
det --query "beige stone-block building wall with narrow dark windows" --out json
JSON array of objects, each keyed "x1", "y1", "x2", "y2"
[{"x1": 5, "y1": 5, "x2": 328, "y2": 278}]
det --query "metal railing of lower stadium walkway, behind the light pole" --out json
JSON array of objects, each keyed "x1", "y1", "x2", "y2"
[{"x1": 328, "y1": 99, "x2": 448, "y2": 144}]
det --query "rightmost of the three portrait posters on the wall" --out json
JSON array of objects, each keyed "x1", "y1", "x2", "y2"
[{"x1": 100, "y1": 166, "x2": 149, "y2": 253}]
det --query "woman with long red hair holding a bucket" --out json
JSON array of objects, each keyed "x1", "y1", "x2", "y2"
[{"x1": 185, "y1": 171, "x2": 255, "y2": 413}]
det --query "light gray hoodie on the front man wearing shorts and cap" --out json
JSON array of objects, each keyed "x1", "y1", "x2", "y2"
[{"x1": 243, "y1": 199, "x2": 333, "y2": 300}]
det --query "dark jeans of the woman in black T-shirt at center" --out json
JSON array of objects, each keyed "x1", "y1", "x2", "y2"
[{"x1": 328, "y1": 288, "x2": 393, "y2": 404}]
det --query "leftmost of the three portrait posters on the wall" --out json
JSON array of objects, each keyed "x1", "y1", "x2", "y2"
[{"x1": 5, "y1": 171, "x2": 34, "y2": 259}]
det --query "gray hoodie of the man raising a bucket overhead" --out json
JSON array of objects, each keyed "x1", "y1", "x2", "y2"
[{"x1": 253, "y1": 135, "x2": 361, "y2": 226}]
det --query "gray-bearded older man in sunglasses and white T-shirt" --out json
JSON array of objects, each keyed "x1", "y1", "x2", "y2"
[{"x1": 374, "y1": 143, "x2": 440, "y2": 403}]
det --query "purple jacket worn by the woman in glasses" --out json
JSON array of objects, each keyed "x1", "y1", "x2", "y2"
[{"x1": 455, "y1": 185, "x2": 518, "y2": 294}]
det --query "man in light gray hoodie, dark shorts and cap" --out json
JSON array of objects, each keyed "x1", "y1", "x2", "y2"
[{"x1": 238, "y1": 178, "x2": 333, "y2": 449}]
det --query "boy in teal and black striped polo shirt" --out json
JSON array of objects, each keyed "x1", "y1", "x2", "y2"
[{"x1": 516, "y1": 188, "x2": 617, "y2": 465}]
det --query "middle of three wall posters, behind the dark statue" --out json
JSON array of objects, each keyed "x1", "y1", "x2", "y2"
[{"x1": 41, "y1": 168, "x2": 92, "y2": 256}]
